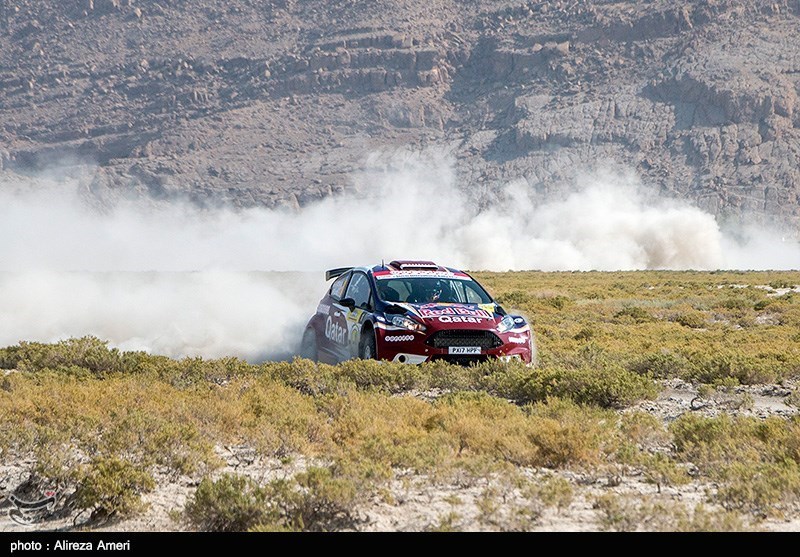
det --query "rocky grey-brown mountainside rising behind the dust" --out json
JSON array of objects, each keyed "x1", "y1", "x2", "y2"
[{"x1": 0, "y1": 0, "x2": 800, "y2": 229}]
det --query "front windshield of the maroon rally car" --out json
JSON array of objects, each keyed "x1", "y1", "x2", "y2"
[{"x1": 376, "y1": 277, "x2": 492, "y2": 304}]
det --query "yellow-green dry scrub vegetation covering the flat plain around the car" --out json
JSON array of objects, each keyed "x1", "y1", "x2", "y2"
[{"x1": 0, "y1": 272, "x2": 800, "y2": 530}]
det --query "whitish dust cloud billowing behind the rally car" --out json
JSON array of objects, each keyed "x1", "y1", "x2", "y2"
[{"x1": 0, "y1": 157, "x2": 800, "y2": 361}]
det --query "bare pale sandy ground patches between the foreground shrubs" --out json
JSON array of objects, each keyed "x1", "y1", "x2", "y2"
[{"x1": 0, "y1": 380, "x2": 800, "y2": 532}]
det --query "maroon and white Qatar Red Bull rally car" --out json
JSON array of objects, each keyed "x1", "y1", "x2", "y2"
[{"x1": 300, "y1": 261, "x2": 535, "y2": 365}]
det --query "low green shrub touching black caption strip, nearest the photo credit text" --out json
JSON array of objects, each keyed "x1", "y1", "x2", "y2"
[{"x1": 184, "y1": 474, "x2": 280, "y2": 532}]
